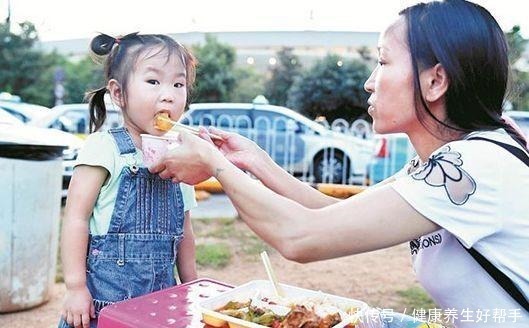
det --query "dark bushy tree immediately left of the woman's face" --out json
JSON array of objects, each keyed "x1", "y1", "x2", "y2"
[{"x1": 288, "y1": 55, "x2": 370, "y2": 121}]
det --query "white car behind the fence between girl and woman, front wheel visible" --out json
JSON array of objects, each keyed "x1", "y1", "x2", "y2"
[{"x1": 181, "y1": 103, "x2": 373, "y2": 183}]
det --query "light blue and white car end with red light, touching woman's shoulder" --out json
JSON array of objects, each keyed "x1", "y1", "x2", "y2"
[{"x1": 368, "y1": 133, "x2": 416, "y2": 184}]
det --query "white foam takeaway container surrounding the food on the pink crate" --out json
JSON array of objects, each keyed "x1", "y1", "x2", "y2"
[{"x1": 198, "y1": 280, "x2": 368, "y2": 328}]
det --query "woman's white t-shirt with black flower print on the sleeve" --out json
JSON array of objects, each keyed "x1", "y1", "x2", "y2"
[{"x1": 392, "y1": 130, "x2": 529, "y2": 328}]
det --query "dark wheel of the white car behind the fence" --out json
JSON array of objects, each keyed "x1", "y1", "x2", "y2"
[{"x1": 314, "y1": 149, "x2": 351, "y2": 183}]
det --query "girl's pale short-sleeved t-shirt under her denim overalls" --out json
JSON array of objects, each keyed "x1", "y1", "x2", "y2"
[{"x1": 75, "y1": 132, "x2": 197, "y2": 235}]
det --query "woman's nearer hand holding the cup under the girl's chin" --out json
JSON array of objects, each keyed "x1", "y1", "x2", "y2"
[{"x1": 149, "y1": 131, "x2": 222, "y2": 185}]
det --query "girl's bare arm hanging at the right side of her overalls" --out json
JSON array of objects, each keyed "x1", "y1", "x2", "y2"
[{"x1": 176, "y1": 211, "x2": 197, "y2": 282}]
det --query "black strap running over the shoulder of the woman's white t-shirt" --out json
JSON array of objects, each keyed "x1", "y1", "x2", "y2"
[{"x1": 462, "y1": 137, "x2": 529, "y2": 312}]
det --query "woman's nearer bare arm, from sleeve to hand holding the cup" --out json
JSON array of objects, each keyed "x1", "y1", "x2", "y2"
[{"x1": 153, "y1": 135, "x2": 439, "y2": 262}]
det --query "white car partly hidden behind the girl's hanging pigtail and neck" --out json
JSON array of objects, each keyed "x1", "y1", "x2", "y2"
[{"x1": 29, "y1": 103, "x2": 123, "y2": 138}]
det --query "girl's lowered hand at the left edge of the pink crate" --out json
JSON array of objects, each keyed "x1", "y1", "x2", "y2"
[{"x1": 61, "y1": 286, "x2": 96, "y2": 328}]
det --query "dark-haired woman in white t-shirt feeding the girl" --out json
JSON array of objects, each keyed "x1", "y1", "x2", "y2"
[{"x1": 153, "y1": 0, "x2": 529, "y2": 327}]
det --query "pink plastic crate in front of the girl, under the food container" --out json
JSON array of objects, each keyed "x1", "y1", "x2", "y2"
[{"x1": 98, "y1": 278, "x2": 233, "y2": 328}]
